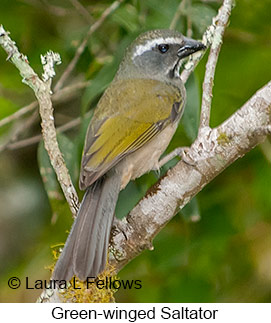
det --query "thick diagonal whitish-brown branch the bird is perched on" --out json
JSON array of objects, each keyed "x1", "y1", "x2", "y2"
[{"x1": 111, "y1": 82, "x2": 271, "y2": 270}]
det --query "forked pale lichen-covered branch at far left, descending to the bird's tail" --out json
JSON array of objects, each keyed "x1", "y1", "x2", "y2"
[{"x1": 0, "y1": 26, "x2": 79, "y2": 215}]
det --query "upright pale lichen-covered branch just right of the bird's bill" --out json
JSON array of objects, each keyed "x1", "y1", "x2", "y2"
[{"x1": 200, "y1": 0, "x2": 232, "y2": 129}]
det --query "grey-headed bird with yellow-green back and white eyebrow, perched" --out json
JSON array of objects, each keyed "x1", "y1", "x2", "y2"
[{"x1": 52, "y1": 30, "x2": 205, "y2": 280}]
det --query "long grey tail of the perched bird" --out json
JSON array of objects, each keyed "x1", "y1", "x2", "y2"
[{"x1": 52, "y1": 174, "x2": 120, "y2": 281}]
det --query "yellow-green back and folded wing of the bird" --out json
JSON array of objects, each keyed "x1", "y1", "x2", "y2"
[{"x1": 80, "y1": 79, "x2": 183, "y2": 189}]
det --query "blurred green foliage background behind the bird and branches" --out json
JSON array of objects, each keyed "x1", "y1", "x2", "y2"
[{"x1": 0, "y1": 0, "x2": 271, "y2": 302}]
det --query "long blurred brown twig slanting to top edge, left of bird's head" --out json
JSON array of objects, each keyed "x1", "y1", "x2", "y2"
[{"x1": 54, "y1": 0, "x2": 124, "y2": 92}]
